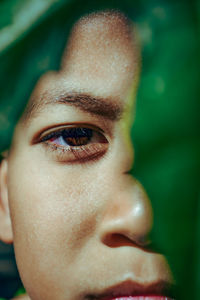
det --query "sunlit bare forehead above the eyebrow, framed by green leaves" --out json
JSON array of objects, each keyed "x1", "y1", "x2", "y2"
[{"x1": 20, "y1": 11, "x2": 139, "y2": 123}]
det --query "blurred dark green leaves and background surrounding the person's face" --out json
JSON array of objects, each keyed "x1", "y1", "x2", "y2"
[{"x1": 0, "y1": 0, "x2": 200, "y2": 300}]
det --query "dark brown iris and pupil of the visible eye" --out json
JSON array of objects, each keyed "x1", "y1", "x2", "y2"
[{"x1": 62, "y1": 128, "x2": 93, "y2": 146}]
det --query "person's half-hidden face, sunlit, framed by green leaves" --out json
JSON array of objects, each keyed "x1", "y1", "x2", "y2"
[{"x1": 1, "y1": 12, "x2": 172, "y2": 300}]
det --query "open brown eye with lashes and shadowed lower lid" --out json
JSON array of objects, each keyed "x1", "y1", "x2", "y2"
[{"x1": 39, "y1": 125, "x2": 108, "y2": 163}]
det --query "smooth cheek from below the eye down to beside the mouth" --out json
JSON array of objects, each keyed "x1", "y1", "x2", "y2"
[{"x1": 8, "y1": 145, "x2": 119, "y2": 300}]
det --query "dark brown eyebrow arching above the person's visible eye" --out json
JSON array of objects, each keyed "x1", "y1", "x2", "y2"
[{"x1": 23, "y1": 92, "x2": 124, "y2": 122}]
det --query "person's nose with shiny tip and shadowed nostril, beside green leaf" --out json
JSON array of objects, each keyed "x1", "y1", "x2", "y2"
[{"x1": 100, "y1": 174, "x2": 153, "y2": 247}]
